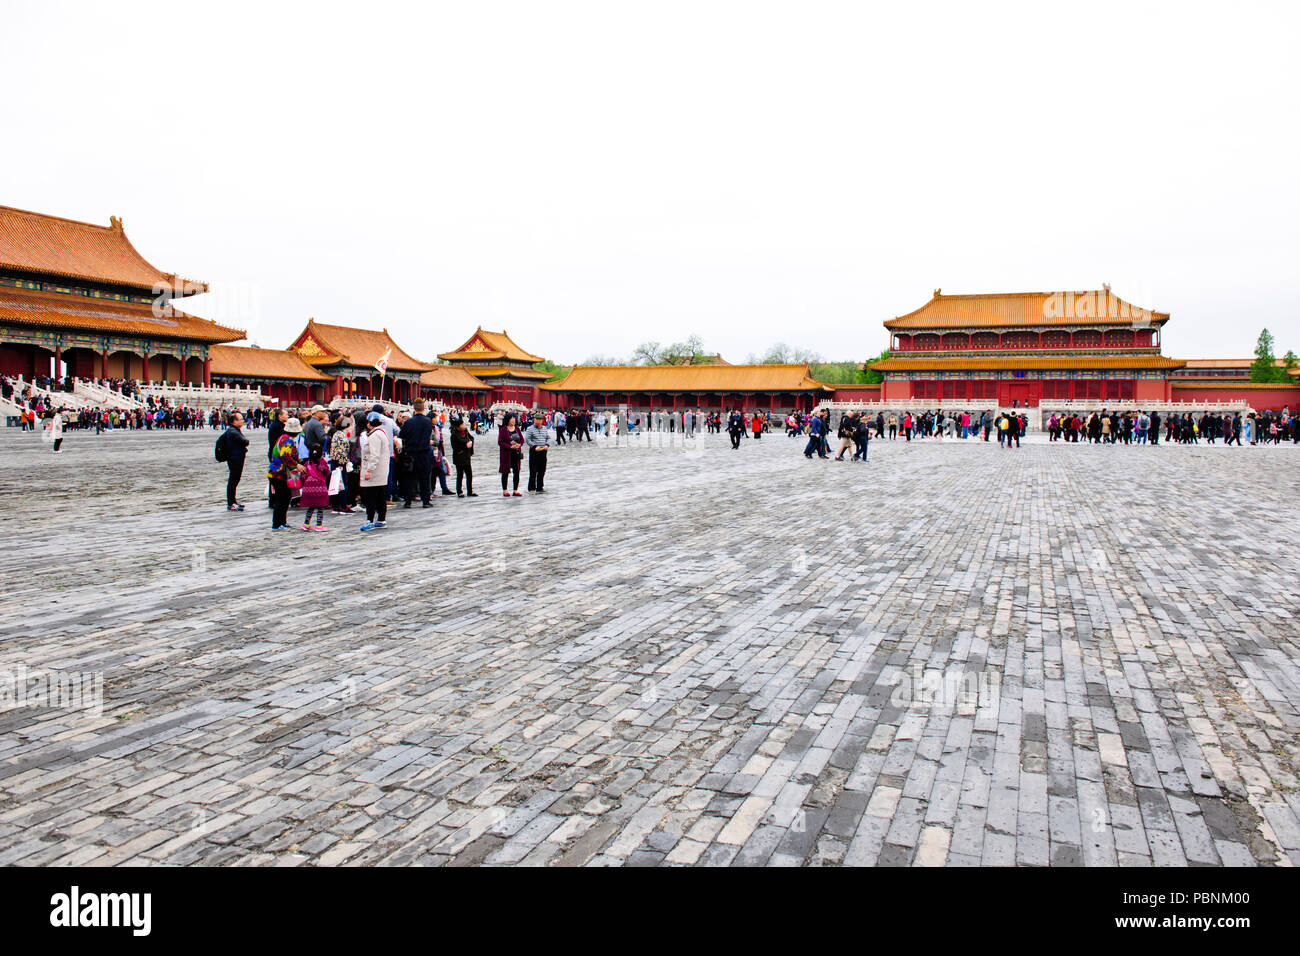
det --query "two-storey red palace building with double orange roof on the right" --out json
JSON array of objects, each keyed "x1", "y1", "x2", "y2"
[{"x1": 870, "y1": 286, "x2": 1187, "y2": 407}]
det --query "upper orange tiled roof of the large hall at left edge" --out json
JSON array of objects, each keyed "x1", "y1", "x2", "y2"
[{"x1": 0, "y1": 206, "x2": 208, "y2": 295}]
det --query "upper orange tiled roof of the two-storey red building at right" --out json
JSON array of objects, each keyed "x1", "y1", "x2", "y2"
[{"x1": 884, "y1": 289, "x2": 1169, "y2": 330}]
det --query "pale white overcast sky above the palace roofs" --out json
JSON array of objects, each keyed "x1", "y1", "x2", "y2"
[{"x1": 0, "y1": 0, "x2": 1300, "y2": 363}]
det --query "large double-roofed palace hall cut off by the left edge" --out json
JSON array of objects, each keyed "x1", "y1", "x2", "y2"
[{"x1": 0, "y1": 206, "x2": 244, "y2": 385}]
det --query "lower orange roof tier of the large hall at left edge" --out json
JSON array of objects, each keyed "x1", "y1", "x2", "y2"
[{"x1": 0, "y1": 287, "x2": 244, "y2": 342}]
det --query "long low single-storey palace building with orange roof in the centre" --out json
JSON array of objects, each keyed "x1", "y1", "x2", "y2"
[{"x1": 541, "y1": 364, "x2": 835, "y2": 414}]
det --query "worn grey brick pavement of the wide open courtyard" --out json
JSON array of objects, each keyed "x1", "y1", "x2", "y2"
[{"x1": 0, "y1": 429, "x2": 1300, "y2": 866}]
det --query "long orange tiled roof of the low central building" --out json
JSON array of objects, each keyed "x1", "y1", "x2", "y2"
[{"x1": 541, "y1": 364, "x2": 831, "y2": 392}]
